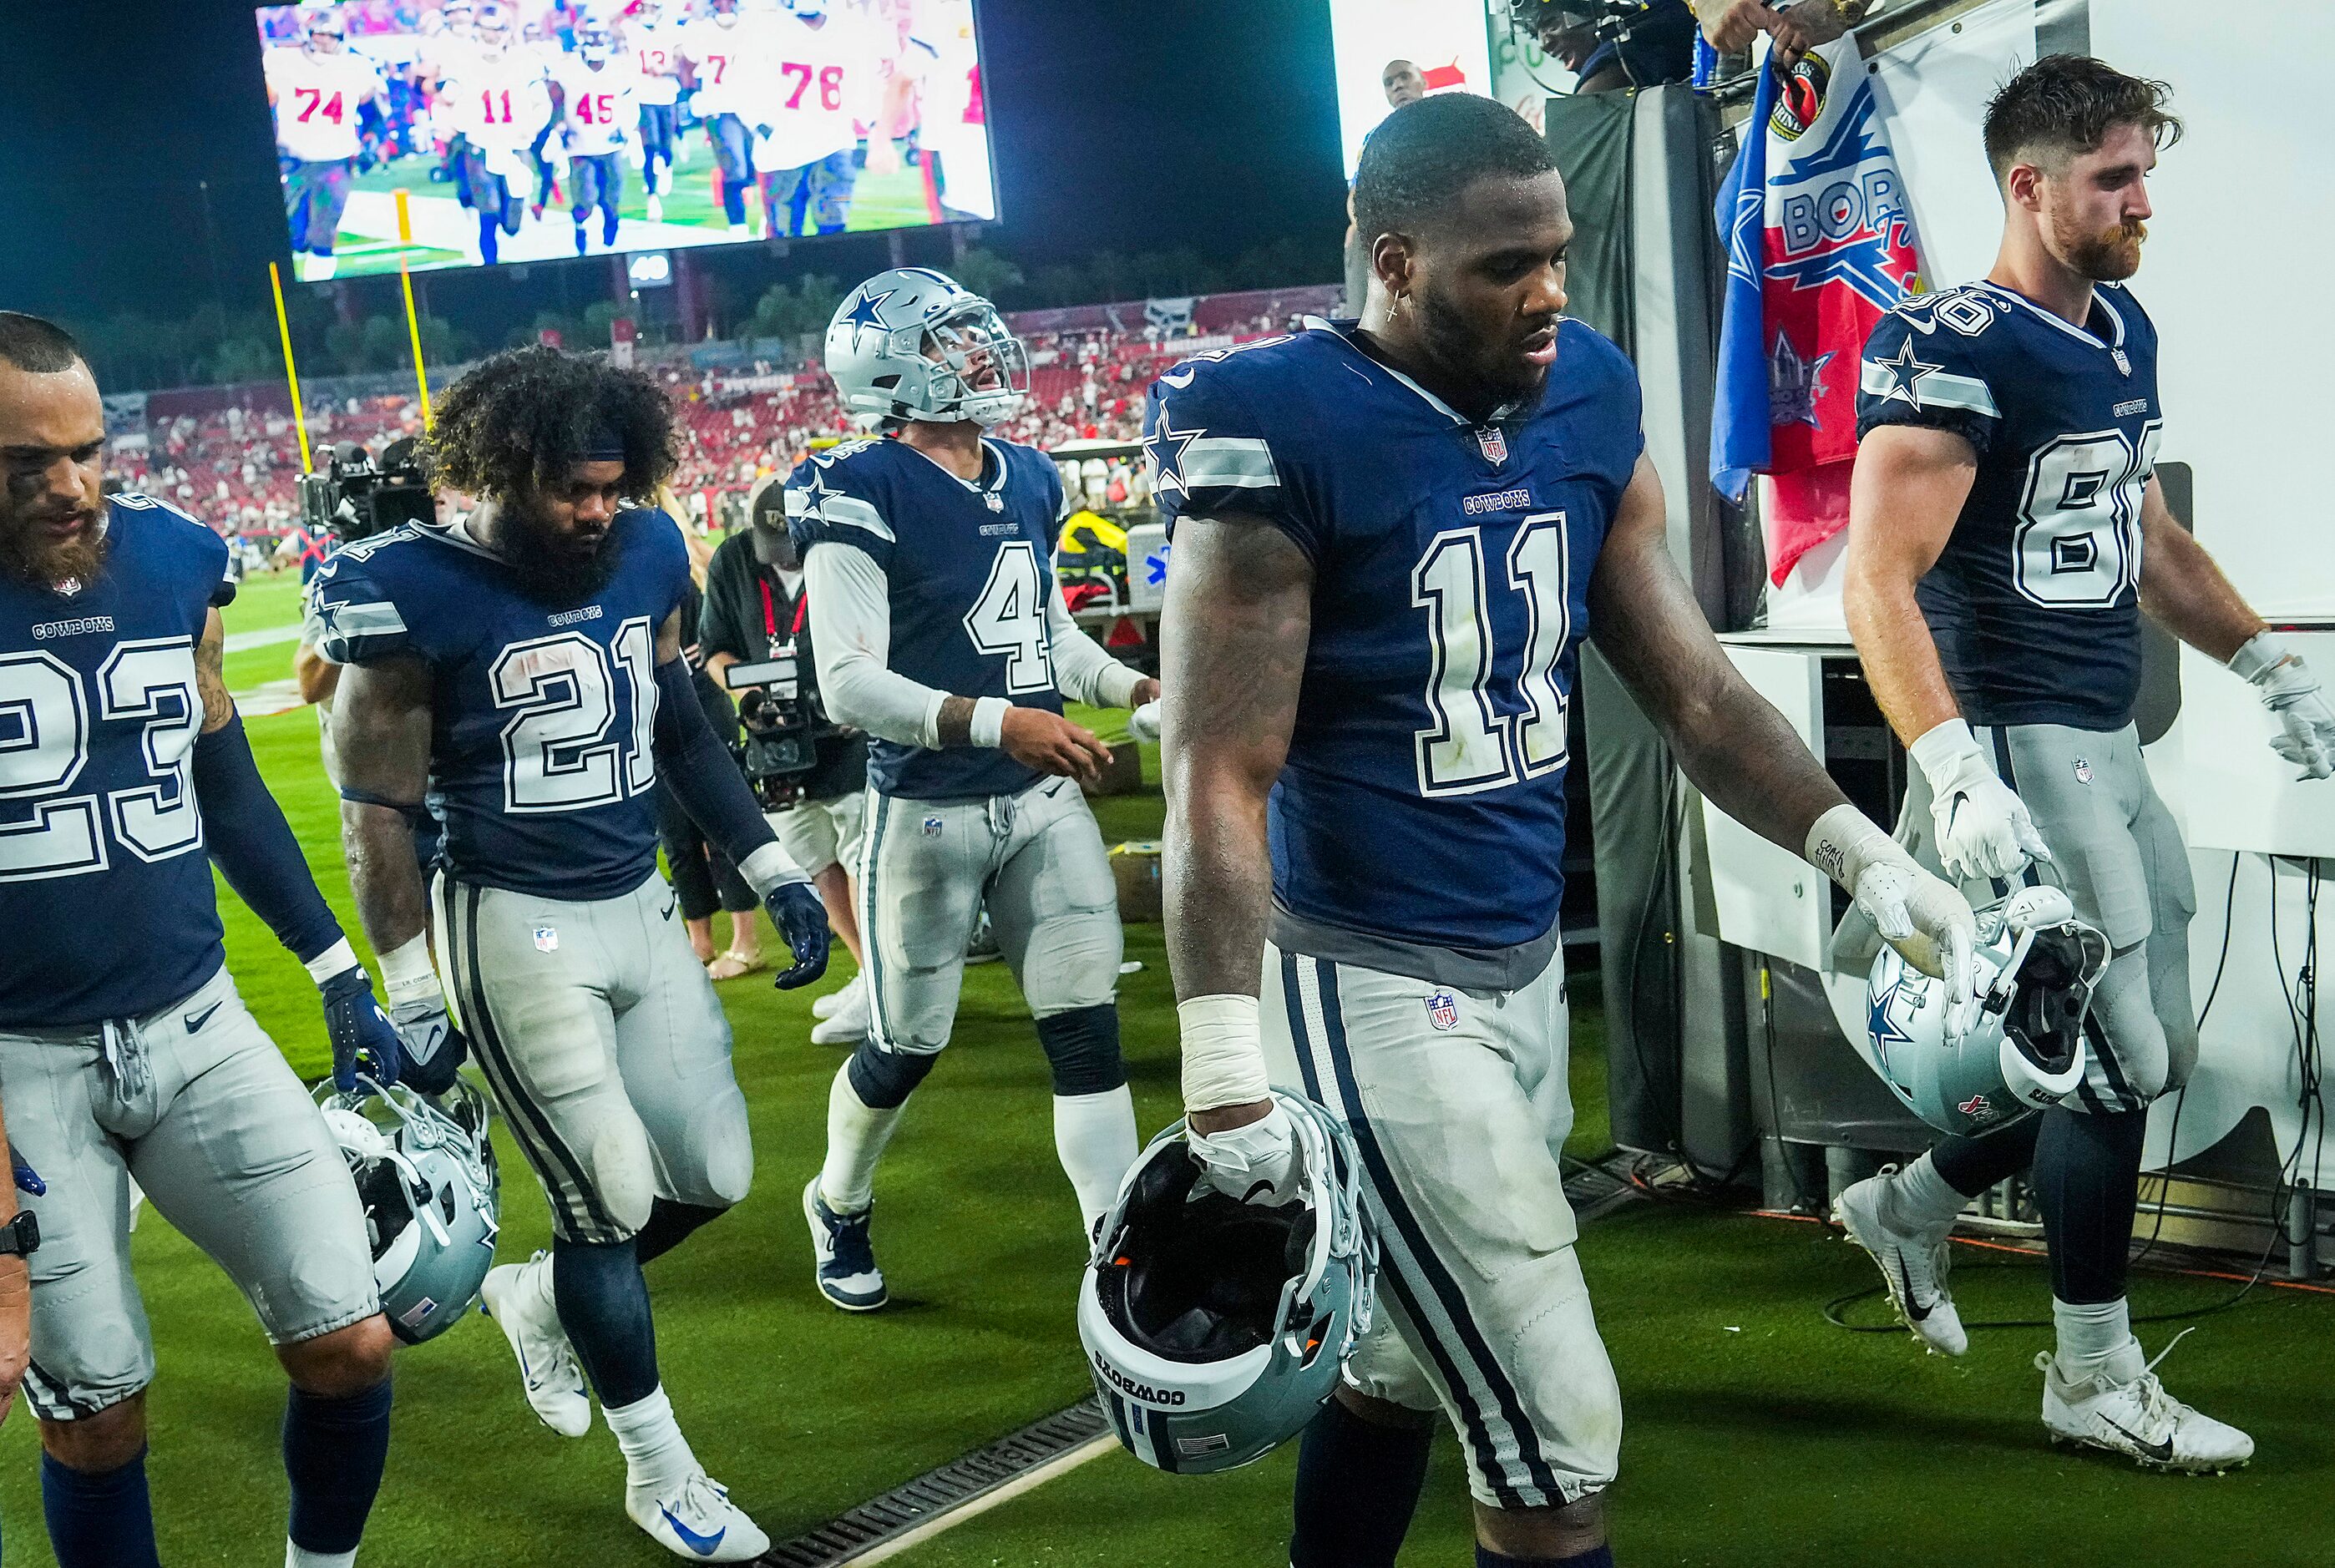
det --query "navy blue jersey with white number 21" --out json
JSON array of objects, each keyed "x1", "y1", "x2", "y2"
[{"x1": 311, "y1": 508, "x2": 689, "y2": 901}]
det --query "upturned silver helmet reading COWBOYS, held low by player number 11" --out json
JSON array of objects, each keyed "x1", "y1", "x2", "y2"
[{"x1": 1079, "y1": 1090, "x2": 1378, "y2": 1474}]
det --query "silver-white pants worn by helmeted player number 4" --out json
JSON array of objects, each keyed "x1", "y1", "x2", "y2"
[{"x1": 859, "y1": 779, "x2": 1123, "y2": 1055}]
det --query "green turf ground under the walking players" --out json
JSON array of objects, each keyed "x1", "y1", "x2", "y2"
[{"x1": 0, "y1": 576, "x2": 2335, "y2": 1568}]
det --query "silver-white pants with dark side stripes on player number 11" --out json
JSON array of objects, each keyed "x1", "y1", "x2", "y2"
[{"x1": 1259, "y1": 945, "x2": 1620, "y2": 1510}]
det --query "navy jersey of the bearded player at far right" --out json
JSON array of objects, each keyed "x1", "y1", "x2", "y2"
[{"x1": 1856, "y1": 282, "x2": 2165, "y2": 731}]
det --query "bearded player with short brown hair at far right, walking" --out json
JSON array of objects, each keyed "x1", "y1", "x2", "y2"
[{"x1": 1840, "y1": 53, "x2": 2335, "y2": 1470}]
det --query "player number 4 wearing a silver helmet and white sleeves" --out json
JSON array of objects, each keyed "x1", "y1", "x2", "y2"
[{"x1": 787, "y1": 266, "x2": 1158, "y2": 1312}]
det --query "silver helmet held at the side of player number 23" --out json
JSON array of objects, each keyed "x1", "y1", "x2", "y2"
[{"x1": 325, "y1": 1078, "x2": 502, "y2": 1344}]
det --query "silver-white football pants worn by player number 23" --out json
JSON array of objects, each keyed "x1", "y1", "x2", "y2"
[{"x1": 0, "y1": 969, "x2": 381, "y2": 1421}]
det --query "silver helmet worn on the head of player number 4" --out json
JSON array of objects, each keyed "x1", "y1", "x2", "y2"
[{"x1": 827, "y1": 266, "x2": 1030, "y2": 429}]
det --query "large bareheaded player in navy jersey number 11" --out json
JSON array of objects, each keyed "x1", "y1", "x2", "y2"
[{"x1": 1147, "y1": 94, "x2": 1973, "y2": 1568}]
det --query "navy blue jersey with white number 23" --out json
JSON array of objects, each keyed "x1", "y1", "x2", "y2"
[{"x1": 0, "y1": 493, "x2": 236, "y2": 1029}]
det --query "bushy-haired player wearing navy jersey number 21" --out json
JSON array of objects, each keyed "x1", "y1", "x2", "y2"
[{"x1": 313, "y1": 347, "x2": 827, "y2": 1563}]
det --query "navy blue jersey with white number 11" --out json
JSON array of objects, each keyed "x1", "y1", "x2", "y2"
[{"x1": 1144, "y1": 320, "x2": 1644, "y2": 952}]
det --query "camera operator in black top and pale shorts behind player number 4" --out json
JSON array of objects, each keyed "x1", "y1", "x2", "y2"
[{"x1": 698, "y1": 473, "x2": 869, "y2": 1045}]
